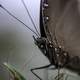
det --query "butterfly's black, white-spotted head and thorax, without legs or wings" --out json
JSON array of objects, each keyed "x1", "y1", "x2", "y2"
[{"x1": 33, "y1": 37, "x2": 69, "y2": 67}]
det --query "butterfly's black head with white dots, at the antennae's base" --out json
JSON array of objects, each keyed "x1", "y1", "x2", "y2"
[{"x1": 34, "y1": 37, "x2": 55, "y2": 64}]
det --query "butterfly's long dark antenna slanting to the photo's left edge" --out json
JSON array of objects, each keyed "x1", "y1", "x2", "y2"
[{"x1": 0, "y1": 4, "x2": 38, "y2": 36}]
